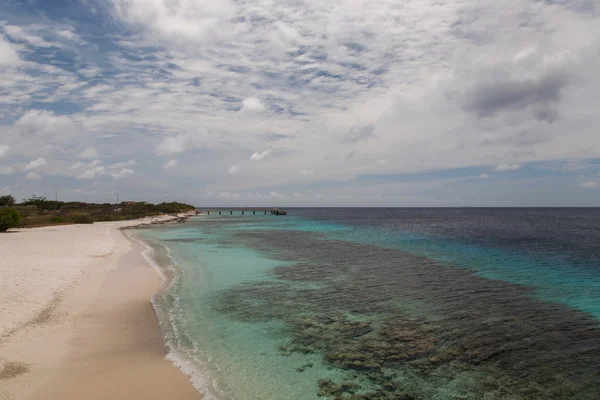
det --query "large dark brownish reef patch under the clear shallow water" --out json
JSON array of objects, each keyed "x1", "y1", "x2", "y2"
[{"x1": 214, "y1": 230, "x2": 600, "y2": 400}]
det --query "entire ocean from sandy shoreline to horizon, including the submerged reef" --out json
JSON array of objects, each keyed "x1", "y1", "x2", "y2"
[{"x1": 135, "y1": 208, "x2": 600, "y2": 400}]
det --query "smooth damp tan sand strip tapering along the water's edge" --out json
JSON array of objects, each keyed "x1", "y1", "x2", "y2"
[{"x1": 32, "y1": 239, "x2": 200, "y2": 400}]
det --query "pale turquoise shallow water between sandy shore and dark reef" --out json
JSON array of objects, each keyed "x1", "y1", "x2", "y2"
[{"x1": 135, "y1": 220, "x2": 343, "y2": 400}]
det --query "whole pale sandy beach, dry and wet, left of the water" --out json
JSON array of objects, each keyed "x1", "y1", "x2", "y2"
[{"x1": 0, "y1": 216, "x2": 200, "y2": 400}]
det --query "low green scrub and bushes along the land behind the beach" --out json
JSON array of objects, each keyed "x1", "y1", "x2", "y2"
[{"x1": 0, "y1": 195, "x2": 195, "y2": 231}]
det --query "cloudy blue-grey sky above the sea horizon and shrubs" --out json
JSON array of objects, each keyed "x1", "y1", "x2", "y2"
[{"x1": 0, "y1": 0, "x2": 600, "y2": 207}]
